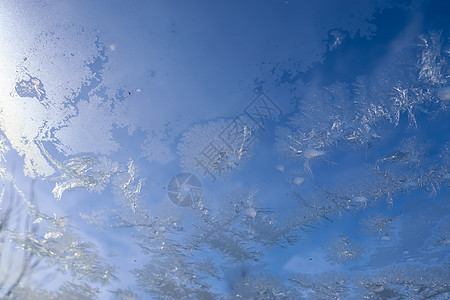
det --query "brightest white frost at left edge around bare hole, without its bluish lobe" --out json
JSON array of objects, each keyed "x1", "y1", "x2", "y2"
[{"x1": 0, "y1": 26, "x2": 102, "y2": 177}]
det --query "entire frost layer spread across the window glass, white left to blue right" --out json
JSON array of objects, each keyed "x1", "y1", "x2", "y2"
[{"x1": 0, "y1": 2, "x2": 450, "y2": 299}]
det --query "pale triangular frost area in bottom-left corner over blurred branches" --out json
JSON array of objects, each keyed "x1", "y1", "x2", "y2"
[{"x1": 0, "y1": 166, "x2": 114, "y2": 299}]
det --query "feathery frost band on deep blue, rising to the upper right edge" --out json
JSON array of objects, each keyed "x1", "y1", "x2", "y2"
[{"x1": 278, "y1": 33, "x2": 447, "y2": 170}]
